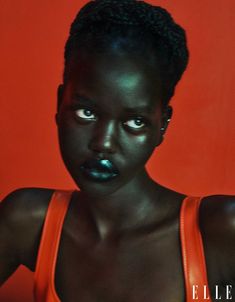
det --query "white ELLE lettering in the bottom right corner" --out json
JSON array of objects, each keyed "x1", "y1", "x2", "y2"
[{"x1": 192, "y1": 285, "x2": 232, "y2": 301}]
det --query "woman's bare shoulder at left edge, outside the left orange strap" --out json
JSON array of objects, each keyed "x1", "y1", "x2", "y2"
[{"x1": 0, "y1": 188, "x2": 54, "y2": 270}]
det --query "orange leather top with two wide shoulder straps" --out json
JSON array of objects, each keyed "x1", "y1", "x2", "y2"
[{"x1": 34, "y1": 191, "x2": 212, "y2": 302}]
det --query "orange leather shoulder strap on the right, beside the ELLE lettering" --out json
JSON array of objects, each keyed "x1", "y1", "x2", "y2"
[{"x1": 180, "y1": 197, "x2": 212, "y2": 302}]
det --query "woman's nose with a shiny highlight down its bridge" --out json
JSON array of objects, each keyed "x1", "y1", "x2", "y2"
[{"x1": 89, "y1": 121, "x2": 118, "y2": 154}]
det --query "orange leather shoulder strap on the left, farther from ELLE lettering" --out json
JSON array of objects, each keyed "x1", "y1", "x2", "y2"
[{"x1": 34, "y1": 191, "x2": 72, "y2": 302}]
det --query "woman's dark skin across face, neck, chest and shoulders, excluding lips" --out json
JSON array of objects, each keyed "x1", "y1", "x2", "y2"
[{"x1": 0, "y1": 50, "x2": 235, "y2": 302}]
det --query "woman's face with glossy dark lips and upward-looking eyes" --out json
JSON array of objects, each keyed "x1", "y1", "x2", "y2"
[{"x1": 57, "y1": 51, "x2": 170, "y2": 195}]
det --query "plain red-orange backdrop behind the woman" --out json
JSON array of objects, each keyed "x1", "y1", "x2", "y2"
[{"x1": 0, "y1": 0, "x2": 235, "y2": 302}]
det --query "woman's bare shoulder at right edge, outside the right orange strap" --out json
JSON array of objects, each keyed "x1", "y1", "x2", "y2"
[{"x1": 200, "y1": 195, "x2": 235, "y2": 280}]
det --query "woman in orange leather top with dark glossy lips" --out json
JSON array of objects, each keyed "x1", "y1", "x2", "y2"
[{"x1": 0, "y1": 0, "x2": 235, "y2": 302}]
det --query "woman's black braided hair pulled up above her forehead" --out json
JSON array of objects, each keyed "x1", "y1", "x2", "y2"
[{"x1": 64, "y1": 0, "x2": 189, "y2": 105}]
